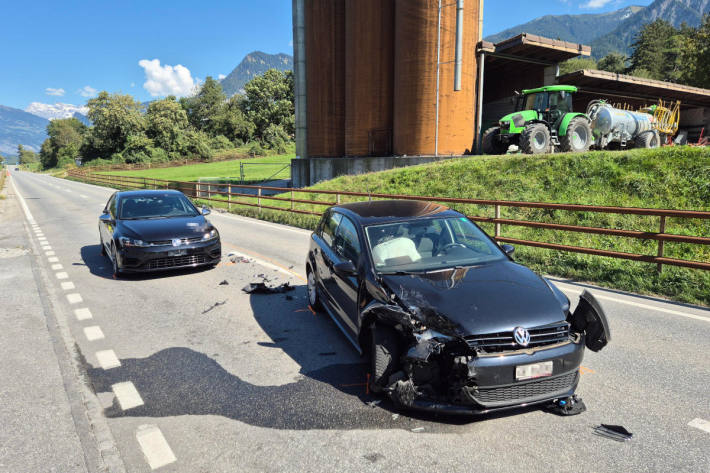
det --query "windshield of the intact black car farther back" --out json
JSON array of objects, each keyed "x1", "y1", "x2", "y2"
[{"x1": 118, "y1": 192, "x2": 199, "y2": 220}]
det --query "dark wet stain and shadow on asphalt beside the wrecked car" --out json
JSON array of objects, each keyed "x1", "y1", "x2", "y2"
[{"x1": 78, "y1": 282, "x2": 544, "y2": 433}]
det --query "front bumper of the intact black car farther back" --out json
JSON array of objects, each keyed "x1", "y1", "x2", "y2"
[{"x1": 117, "y1": 238, "x2": 222, "y2": 273}]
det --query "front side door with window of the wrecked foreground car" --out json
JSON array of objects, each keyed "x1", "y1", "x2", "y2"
[{"x1": 331, "y1": 216, "x2": 362, "y2": 336}]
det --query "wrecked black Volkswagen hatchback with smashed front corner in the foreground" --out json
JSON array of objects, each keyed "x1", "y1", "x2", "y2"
[{"x1": 306, "y1": 201, "x2": 610, "y2": 415}]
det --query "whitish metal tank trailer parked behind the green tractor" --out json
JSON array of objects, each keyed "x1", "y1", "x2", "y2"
[{"x1": 587, "y1": 100, "x2": 660, "y2": 149}]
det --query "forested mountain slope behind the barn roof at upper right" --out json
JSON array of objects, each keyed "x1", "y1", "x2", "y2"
[{"x1": 485, "y1": 0, "x2": 710, "y2": 59}]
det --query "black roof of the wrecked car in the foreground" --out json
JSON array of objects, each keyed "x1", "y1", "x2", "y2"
[{"x1": 332, "y1": 200, "x2": 461, "y2": 225}]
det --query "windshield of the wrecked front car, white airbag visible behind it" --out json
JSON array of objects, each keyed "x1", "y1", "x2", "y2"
[{"x1": 366, "y1": 217, "x2": 505, "y2": 273}]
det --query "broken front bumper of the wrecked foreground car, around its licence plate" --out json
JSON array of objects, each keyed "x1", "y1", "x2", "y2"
[{"x1": 388, "y1": 335, "x2": 584, "y2": 414}]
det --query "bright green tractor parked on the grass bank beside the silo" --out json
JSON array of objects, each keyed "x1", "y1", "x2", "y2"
[{"x1": 482, "y1": 85, "x2": 594, "y2": 154}]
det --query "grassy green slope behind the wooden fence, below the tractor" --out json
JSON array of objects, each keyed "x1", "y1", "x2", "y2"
[{"x1": 191, "y1": 147, "x2": 710, "y2": 305}]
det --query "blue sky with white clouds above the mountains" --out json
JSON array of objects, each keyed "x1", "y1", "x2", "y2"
[{"x1": 0, "y1": 0, "x2": 650, "y2": 109}]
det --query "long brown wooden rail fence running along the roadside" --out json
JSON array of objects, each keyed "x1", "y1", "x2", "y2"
[{"x1": 69, "y1": 170, "x2": 710, "y2": 272}]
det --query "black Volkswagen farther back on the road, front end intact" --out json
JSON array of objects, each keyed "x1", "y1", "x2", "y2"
[{"x1": 99, "y1": 190, "x2": 222, "y2": 277}]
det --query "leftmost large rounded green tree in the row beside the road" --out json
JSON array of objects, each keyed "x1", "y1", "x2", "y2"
[{"x1": 39, "y1": 118, "x2": 86, "y2": 169}]
